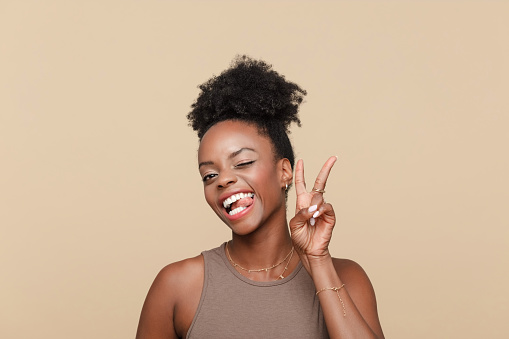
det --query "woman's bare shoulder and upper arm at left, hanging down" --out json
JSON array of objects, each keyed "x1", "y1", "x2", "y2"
[{"x1": 136, "y1": 255, "x2": 204, "y2": 339}]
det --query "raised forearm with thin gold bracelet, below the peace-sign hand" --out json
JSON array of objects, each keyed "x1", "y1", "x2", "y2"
[{"x1": 308, "y1": 256, "x2": 377, "y2": 339}]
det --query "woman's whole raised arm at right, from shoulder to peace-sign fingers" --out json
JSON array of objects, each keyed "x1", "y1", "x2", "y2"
[{"x1": 290, "y1": 157, "x2": 384, "y2": 339}]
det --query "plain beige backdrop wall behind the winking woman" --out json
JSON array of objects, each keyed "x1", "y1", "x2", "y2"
[{"x1": 0, "y1": 0, "x2": 509, "y2": 339}]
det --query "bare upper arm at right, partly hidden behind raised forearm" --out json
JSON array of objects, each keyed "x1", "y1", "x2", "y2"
[{"x1": 334, "y1": 258, "x2": 384, "y2": 338}]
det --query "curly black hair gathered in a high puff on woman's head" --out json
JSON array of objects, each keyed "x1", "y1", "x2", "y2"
[{"x1": 187, "y1": 55, "x2": 306, "y2": 168}]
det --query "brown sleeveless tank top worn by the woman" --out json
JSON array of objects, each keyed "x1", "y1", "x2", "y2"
[{"x1": 187, "y1": 243, "x2": 329, "y2": 339}]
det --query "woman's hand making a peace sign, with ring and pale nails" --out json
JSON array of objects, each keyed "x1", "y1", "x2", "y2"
[{"x1": 290, "y1": 157, "x2": 337, "y2": 271}]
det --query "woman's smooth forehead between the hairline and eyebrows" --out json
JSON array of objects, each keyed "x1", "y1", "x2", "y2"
[{"x1": 198, "y1": 120, "x2": 272, "y2": 161}]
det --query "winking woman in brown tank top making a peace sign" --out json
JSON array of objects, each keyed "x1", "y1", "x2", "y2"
[{"x1": 137, "y1": 56, "x2": 383, "y2": 339}]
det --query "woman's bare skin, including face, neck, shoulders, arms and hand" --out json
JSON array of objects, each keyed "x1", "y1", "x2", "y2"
[{"x1": 136, "y1": 121, "x2": 384, "y2": 339}]
